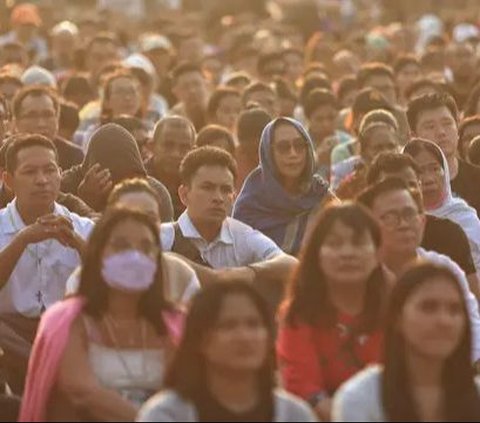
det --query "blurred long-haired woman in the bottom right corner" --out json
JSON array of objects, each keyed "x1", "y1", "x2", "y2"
[{"x1": 333, "y1": 263, "x2": 480, "y2": 422}]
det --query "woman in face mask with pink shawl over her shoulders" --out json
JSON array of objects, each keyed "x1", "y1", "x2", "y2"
[{"x1": 20, "y1": 209, "x2": 182, "y2": 421}]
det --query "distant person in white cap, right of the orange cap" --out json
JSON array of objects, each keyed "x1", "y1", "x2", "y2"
[{"x1": 41, "y1": 21, "x2": 79, "y2": 76}]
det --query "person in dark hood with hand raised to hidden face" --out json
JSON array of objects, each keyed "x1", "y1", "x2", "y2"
[{"x1": 62, "y1": 123, "x2": 173, "y2": 222}]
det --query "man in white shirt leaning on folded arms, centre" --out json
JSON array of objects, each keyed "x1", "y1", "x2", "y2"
[{"x1": 161, "y1": 147, "x2": 297, "y2": 284}]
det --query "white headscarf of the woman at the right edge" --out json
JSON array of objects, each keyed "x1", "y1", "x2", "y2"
[{"x1": 404, "y1": 140, "x2": 480, "y2": 275}]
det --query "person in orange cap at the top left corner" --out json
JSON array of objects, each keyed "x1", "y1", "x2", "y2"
[{"x1": 0, "y1": 3, "x2": 48, "y2": 61}]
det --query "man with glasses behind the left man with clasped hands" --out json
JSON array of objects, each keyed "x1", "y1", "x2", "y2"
[{"x1": 12, "y1": 86, "x2": 83, "y2": 171}]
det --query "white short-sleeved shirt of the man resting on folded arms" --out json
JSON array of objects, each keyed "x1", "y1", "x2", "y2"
[{"x1": 160, "y1": 211, "x2": 283, "y2": 269}]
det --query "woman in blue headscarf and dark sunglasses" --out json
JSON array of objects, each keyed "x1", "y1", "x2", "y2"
[{"x1": 233, "y1": 118, "x2": 334, "y2": 254}]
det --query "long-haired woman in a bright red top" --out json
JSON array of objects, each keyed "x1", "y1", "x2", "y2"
[{"x1": 277, "y1": 204, "x2": 388, "y2": 421}]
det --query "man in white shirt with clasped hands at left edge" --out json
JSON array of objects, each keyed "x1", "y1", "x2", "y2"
[{"x1": 0, "y1": 135, "x2": 93, "y2": 394}]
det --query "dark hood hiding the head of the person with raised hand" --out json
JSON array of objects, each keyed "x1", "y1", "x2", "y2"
[{"x1": 82, "y1": 123, "x2": 147, "y2": 185}]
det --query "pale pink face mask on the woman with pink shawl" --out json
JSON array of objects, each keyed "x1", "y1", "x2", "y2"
[{"x1": 102, "y1": 250, "x2": 157, "y2": 293}]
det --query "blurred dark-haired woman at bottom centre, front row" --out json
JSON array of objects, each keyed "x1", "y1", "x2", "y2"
[{"x1": 137, "y1": 282, "x2": 315, "y2": 422}]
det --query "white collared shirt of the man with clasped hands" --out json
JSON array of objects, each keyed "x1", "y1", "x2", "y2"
[{"x1": 0, "y1": 200, "x2": 94, "y2": 317}]
